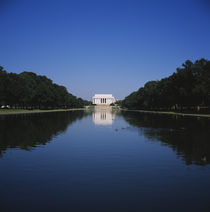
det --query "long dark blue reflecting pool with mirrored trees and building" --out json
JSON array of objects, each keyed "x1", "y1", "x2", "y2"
[{"x1": 0, "y1": 108, "x2": 210, "y2": 212}]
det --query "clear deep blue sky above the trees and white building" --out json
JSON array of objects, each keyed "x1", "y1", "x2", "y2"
[{"x1": 0, "y1": 0, "x2": 210, "y2": 99}]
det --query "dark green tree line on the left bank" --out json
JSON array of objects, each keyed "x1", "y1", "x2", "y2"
[{"x1": 0, "y1": 66, "x2": 89, "y2": 109}]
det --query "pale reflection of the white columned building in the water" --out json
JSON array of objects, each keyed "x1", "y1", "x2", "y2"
[{"x1": 93, "y1": 106, "x2": 115, "y2": 125}]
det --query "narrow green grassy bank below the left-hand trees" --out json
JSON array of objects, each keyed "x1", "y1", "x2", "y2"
[{"x1": 0, "y1": 108, "x2": 84, "y2": 115}]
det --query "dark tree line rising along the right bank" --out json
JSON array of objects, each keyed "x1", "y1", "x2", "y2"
[{"x1": 121, "y1": 59, "x2": 210, "y2": 110}]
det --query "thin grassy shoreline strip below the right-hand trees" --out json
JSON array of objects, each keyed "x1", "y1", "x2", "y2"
[{"x1": 121, "y1": 109, "x2": 210, "y2": 118}]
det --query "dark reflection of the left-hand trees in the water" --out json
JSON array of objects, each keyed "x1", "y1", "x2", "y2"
[{"x1": 0, "y1": 111, "x2": 87, "y2": 156}]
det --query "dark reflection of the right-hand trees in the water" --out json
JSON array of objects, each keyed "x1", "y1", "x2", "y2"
[{"x1": 122, "y1": 112, "x2": 210, "y2": 165}]
